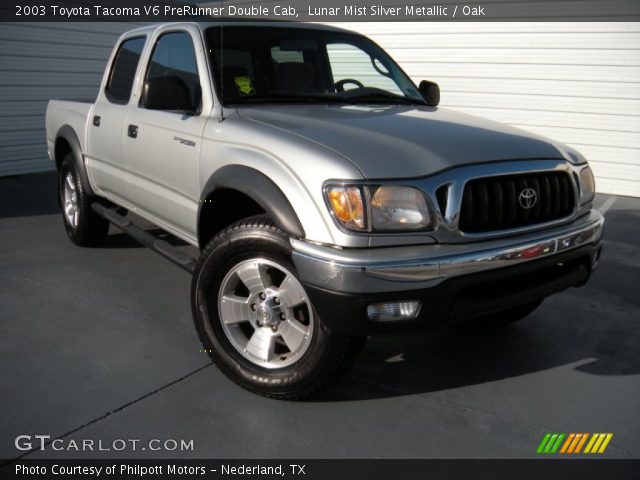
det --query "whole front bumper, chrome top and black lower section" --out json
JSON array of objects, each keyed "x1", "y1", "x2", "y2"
[{"x1": 292, "y1": 211, "x2": 604, "y2": 334}]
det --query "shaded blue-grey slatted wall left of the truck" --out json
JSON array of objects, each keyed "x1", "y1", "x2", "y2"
[{"x1": 0, "y1": 22, "x2": 142, "y2": 175}]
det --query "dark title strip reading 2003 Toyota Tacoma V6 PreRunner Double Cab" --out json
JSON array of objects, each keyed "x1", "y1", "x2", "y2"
[{"x1": 0, "y1": 0, "x2": 640, "y2": 22}]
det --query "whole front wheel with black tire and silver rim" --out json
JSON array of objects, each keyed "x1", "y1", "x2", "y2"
[{"x1": 191, "y1": 215, "x2": 365, "y2": 400}]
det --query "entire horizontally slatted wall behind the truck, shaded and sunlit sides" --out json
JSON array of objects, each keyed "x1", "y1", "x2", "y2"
[{"x1": 0, "y1": 22, "x2": 640, "y2": 196}]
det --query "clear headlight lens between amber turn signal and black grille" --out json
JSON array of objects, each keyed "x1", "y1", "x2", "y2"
[{"x1": 371, "y1": 186, "x2": 431, "y2": 230}]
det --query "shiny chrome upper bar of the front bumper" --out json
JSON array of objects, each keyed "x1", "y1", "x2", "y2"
[{"x1": 291, "y1": 211, "x2": 604, "y2": 293}]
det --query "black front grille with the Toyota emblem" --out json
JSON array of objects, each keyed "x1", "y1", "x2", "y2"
[{"x1": 460, "y1": 172, "x2": 575, "y2": 233}]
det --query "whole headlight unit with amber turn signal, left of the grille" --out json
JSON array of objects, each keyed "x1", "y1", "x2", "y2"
[{"x1": 325, "y1": 185, "x2": 431, "y2": 232}]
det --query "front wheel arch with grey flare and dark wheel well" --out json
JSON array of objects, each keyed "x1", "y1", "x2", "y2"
[{"x1": 198, "y1": 165, "x2": 305, "y2": 248}]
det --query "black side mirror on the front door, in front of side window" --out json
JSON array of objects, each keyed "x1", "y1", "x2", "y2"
[{"x1": 142, "y1": 75, "x2": 195, "y2": 112}]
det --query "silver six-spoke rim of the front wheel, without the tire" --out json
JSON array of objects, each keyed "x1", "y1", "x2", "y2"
[{"x1": 218, "y1": 258, "x2": 315, "y2": 369}]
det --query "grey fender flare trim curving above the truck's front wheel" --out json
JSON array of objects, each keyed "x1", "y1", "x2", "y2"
[{"x1": 198, "y1": 165, "x2": 304, "y2": 238}]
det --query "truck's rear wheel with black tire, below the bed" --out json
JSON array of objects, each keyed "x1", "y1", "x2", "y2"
[{"x1": 58, "y1": 153, "x2": 109, "y2": 247}]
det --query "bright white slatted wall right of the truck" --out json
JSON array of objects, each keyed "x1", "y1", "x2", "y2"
[{"x1": 335, "y1": 22, "x2": 640, "y2": 197}]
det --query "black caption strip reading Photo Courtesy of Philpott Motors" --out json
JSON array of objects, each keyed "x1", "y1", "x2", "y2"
[{"x1": 0, "y1": 459, "x2": 640, "y2": 480}]
